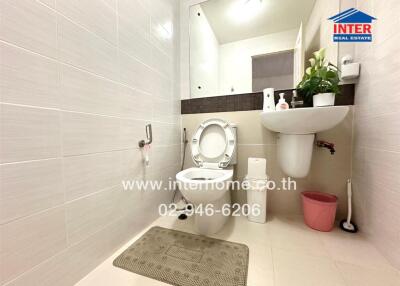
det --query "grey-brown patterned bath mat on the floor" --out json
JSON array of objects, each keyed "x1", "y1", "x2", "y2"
[{"x1": 113, "y1": 226, "x2": 249, "y2": 286}]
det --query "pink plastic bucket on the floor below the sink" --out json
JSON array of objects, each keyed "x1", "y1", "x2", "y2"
[{"x1": 301, "y1": 192, "x2": 337, "y2": 231}]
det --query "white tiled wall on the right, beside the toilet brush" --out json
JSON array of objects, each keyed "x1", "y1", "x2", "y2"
[{"x1": 353, "y1": 0, "x2": 400, "y2": 268}]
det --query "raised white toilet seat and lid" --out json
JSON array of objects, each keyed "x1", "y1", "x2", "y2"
[{"x1": 191, "y1": 119, "x2": 236, "y2": 168}]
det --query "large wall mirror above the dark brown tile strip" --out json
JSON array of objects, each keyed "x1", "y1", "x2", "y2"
[{"x1": 189, "y1": 0, "x2": 339, "y2": 98}]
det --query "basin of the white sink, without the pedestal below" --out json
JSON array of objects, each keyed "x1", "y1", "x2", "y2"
[{"x1": 261, "y1": 106, "x2": 349, "y2": 134}]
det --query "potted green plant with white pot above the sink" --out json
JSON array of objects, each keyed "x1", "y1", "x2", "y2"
[{"x1": 297, "y1": 48, "x2": 340, "y2": 106}]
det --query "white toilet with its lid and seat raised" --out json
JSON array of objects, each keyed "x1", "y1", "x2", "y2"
[{"x1": 176, "y1": 119, "x2": 237, "y2": 235}]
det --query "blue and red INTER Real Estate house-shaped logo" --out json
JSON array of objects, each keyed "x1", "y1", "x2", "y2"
[{"x1": 328, "y1": 8, "x2": 376, "y2": 42}]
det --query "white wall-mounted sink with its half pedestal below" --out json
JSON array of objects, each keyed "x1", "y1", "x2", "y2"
[{"x1": 260, "y1": 106, "x2": 350, "y2": 178}]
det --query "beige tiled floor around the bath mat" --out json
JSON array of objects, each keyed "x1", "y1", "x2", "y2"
[{"x1": 76, "y1": 216, "x2": 400, "y2": 286}]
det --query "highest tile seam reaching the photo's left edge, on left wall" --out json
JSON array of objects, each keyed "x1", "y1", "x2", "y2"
[{"x1": 0, "y1": 39, "x2": 161, "y2": 96}]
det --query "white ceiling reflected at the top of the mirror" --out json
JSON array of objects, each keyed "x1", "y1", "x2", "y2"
[{"x1": 200, "y1": 0, "x2": 315, "y2": 44}]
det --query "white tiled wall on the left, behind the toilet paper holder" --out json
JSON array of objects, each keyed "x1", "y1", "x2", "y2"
[{"x1": 0, "y1": 0, "x2": 180, "y2": 286}]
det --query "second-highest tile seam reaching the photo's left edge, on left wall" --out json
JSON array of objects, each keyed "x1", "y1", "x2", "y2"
[{"x1": 0, "y1": 101, "x2": 179, "y2": 125}]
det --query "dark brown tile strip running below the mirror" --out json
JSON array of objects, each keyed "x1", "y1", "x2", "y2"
[{"x1": 181, "y1": 84, "x2": 355, "y2": 114}]
